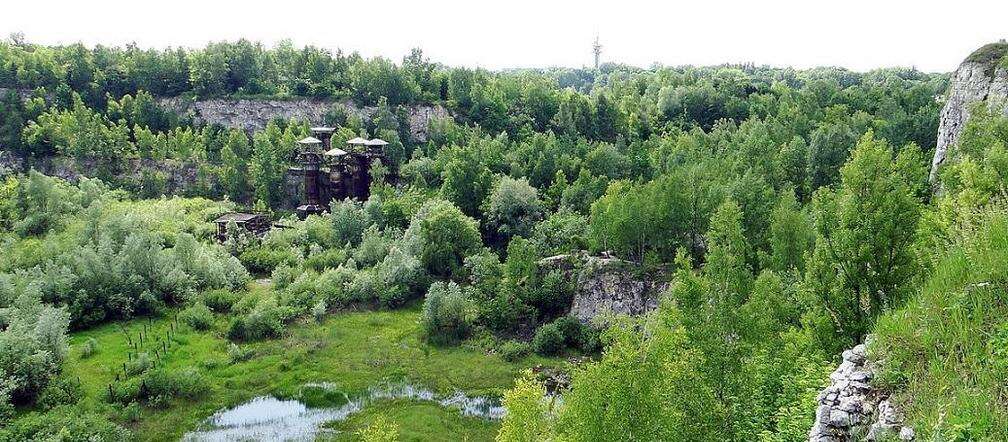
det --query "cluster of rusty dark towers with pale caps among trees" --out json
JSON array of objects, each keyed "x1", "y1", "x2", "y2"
[{"x1": 290, "y1": 127, "x2": 388, "y2": 218}]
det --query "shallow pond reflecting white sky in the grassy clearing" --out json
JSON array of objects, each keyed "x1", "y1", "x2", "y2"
[{"x1": 182, "y1": 383, "x2": 504, "y2": 442}]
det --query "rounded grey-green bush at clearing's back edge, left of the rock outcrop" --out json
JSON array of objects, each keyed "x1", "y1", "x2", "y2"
[{"x1": 420, "y1": 282, "x2": 474, "y2": 344}]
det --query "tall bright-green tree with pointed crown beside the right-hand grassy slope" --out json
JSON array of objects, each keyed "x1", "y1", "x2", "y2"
[{"x1": 805, "y1": 131, "x2": 920, "y2": 345}]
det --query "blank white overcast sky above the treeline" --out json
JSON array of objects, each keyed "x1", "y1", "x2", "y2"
[{"x1": 0, "y1": 0, "x2": 1008, "y2": 72}]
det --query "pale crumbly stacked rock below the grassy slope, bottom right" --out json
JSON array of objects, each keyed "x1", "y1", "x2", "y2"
[{"x1": 808, "y1": 344, "x2": 914, "y2": 442}]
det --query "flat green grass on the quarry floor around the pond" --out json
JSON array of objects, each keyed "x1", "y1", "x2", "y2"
[{"x1": 52, "y1": 287, "x2": 555, "y2": 441}]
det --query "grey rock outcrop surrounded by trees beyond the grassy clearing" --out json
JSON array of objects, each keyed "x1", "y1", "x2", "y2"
[{"x1": 539, "y1": 255, "x2": 668, "y2": 323}]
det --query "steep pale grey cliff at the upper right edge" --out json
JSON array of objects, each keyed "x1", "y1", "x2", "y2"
[{"x1": 930, "y1": 42, "x2": 1008, "y2": 183}]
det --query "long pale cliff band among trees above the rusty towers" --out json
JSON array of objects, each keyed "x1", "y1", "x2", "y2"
[{"x1": 158, "y1": 97, "x2": 451, "y2": 142}]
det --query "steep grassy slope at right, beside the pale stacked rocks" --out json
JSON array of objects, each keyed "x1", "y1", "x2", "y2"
[{"x1": 870, "y1": 209, "x2": 1008, "y2": 441}]
